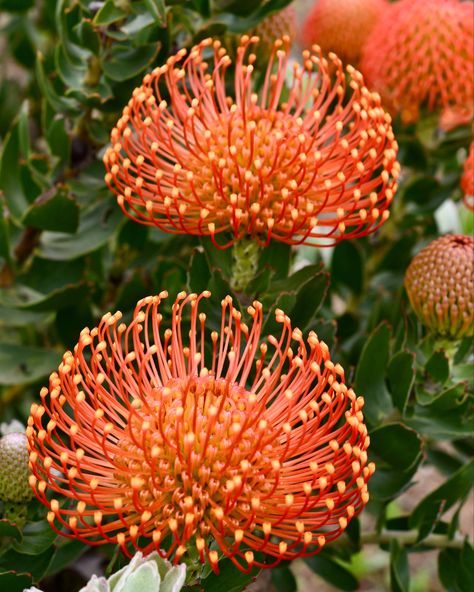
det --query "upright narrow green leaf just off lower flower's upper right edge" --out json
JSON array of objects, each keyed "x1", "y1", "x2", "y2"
[{"x1": 355, "y1": 323, "x2": 392, "y2": 424}]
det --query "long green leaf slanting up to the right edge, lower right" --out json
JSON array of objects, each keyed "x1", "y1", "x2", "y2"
[{"x1": 410, "y1": 460, "x2": 474, "y2": 540}]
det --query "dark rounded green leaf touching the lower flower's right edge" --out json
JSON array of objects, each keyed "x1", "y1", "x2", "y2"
[{"x1": 370, "y1": 423, "x2": 422, "y2": 471}]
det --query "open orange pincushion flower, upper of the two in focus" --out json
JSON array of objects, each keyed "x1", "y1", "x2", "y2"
[{"x1": 104, "y1": 36, "x2": 399, "y2": 248}]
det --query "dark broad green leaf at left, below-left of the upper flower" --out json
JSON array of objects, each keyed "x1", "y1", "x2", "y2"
[{"x1": 22, "y1": 186, "x2": 79, "y2": 233}]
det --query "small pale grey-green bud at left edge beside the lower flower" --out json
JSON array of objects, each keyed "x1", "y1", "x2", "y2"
[{"x1": 0, "y1": 432, "x2": 33, "y2": 503}]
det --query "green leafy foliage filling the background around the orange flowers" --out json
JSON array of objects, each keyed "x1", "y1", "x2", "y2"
[{"x1": 0, "y1": 0, "x2": 474, "y2": 592}]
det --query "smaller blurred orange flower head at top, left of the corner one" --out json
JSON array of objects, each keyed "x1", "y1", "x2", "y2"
[{"x1": 301, "y1": 0, "x2": 389, "y2": 65}]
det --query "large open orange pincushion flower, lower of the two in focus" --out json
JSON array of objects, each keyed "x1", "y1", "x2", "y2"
[{"x1": 27, "y1": 292, "x2": 374, "y2": 571}]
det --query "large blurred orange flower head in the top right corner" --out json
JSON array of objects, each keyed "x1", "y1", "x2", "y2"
[{"x1": 360, "y1": 0, "x2": 474, "y2": 122}]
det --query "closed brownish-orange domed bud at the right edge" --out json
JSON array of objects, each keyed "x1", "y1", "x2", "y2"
[{"x1": 405, "y1": 235, "x2": 474, "y2": 339}]
